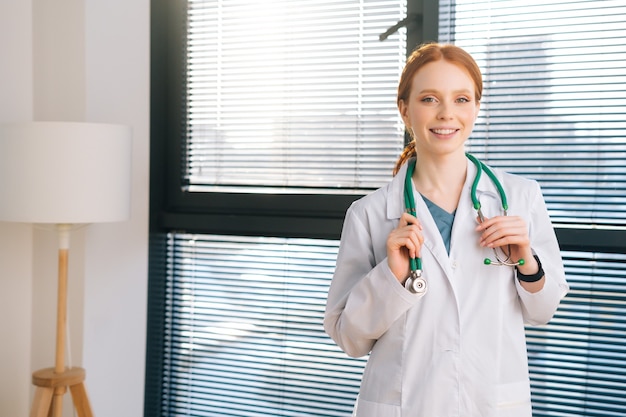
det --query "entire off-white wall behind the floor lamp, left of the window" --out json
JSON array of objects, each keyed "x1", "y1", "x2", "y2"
[{"x1": 0, "y1": 0, "x2": 149, "y2": 417}]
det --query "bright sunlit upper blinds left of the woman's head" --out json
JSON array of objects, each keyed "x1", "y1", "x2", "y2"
[{"x1": 183, "y1": 0, "x2": 406, "y2": 192}]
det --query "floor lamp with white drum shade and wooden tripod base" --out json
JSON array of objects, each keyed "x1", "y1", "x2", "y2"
[{"x1": 0, "y1": 122, "x2": 131, "y2": 417}]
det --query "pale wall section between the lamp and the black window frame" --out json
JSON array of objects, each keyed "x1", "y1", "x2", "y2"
[{"x1": 84, "y1": 0, "x2": 150, "y2": 417}]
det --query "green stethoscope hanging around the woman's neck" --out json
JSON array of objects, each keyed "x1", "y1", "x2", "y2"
[{"x1": 404, "y1": 153, "x2": 524, "y2": 294}]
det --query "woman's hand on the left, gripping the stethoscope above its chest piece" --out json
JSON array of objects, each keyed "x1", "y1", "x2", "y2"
[{"x1": 387, "y1": 213, "x2": 424, "y2": 283}]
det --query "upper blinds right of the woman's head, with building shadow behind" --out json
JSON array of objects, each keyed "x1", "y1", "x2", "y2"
[{"x1": 440, "y1": 0, "x2": 626, "y2": 226}]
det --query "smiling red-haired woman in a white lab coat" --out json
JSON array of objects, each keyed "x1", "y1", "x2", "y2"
[{"x1": 324, "y1": 44, "x2": 568, "y2": 417}]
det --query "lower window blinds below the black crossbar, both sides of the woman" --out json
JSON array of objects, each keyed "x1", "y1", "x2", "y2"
[{"x1": 161, "y1": 234, "x2": 626, "y2": 417}]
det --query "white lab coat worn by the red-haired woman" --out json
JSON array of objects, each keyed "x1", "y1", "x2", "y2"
[{"x1": 324, "y1": 157, "x2": 568, "y2": 417}]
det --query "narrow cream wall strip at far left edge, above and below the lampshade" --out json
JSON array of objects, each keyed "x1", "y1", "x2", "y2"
[{"x1": 0, "y1": 0, "x2": 33, "y2": 417}]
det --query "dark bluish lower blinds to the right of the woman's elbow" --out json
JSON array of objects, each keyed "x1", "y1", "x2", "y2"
[{"x1": 526, "y1": 252, "x2": 626, "y2": 417}]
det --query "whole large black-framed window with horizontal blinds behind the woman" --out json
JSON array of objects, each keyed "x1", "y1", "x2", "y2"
[{"x1": 145, "y1": 0, "x2": 626, "y2": 417}]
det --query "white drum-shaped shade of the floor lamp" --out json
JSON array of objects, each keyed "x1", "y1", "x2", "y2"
[{"x1": 0, "y1": 122, "x2": 132, "y2": 224}]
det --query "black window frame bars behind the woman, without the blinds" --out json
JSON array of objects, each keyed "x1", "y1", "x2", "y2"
[{"x1": 144, "y1": 0, "x2": 626, "y2": 416}]
